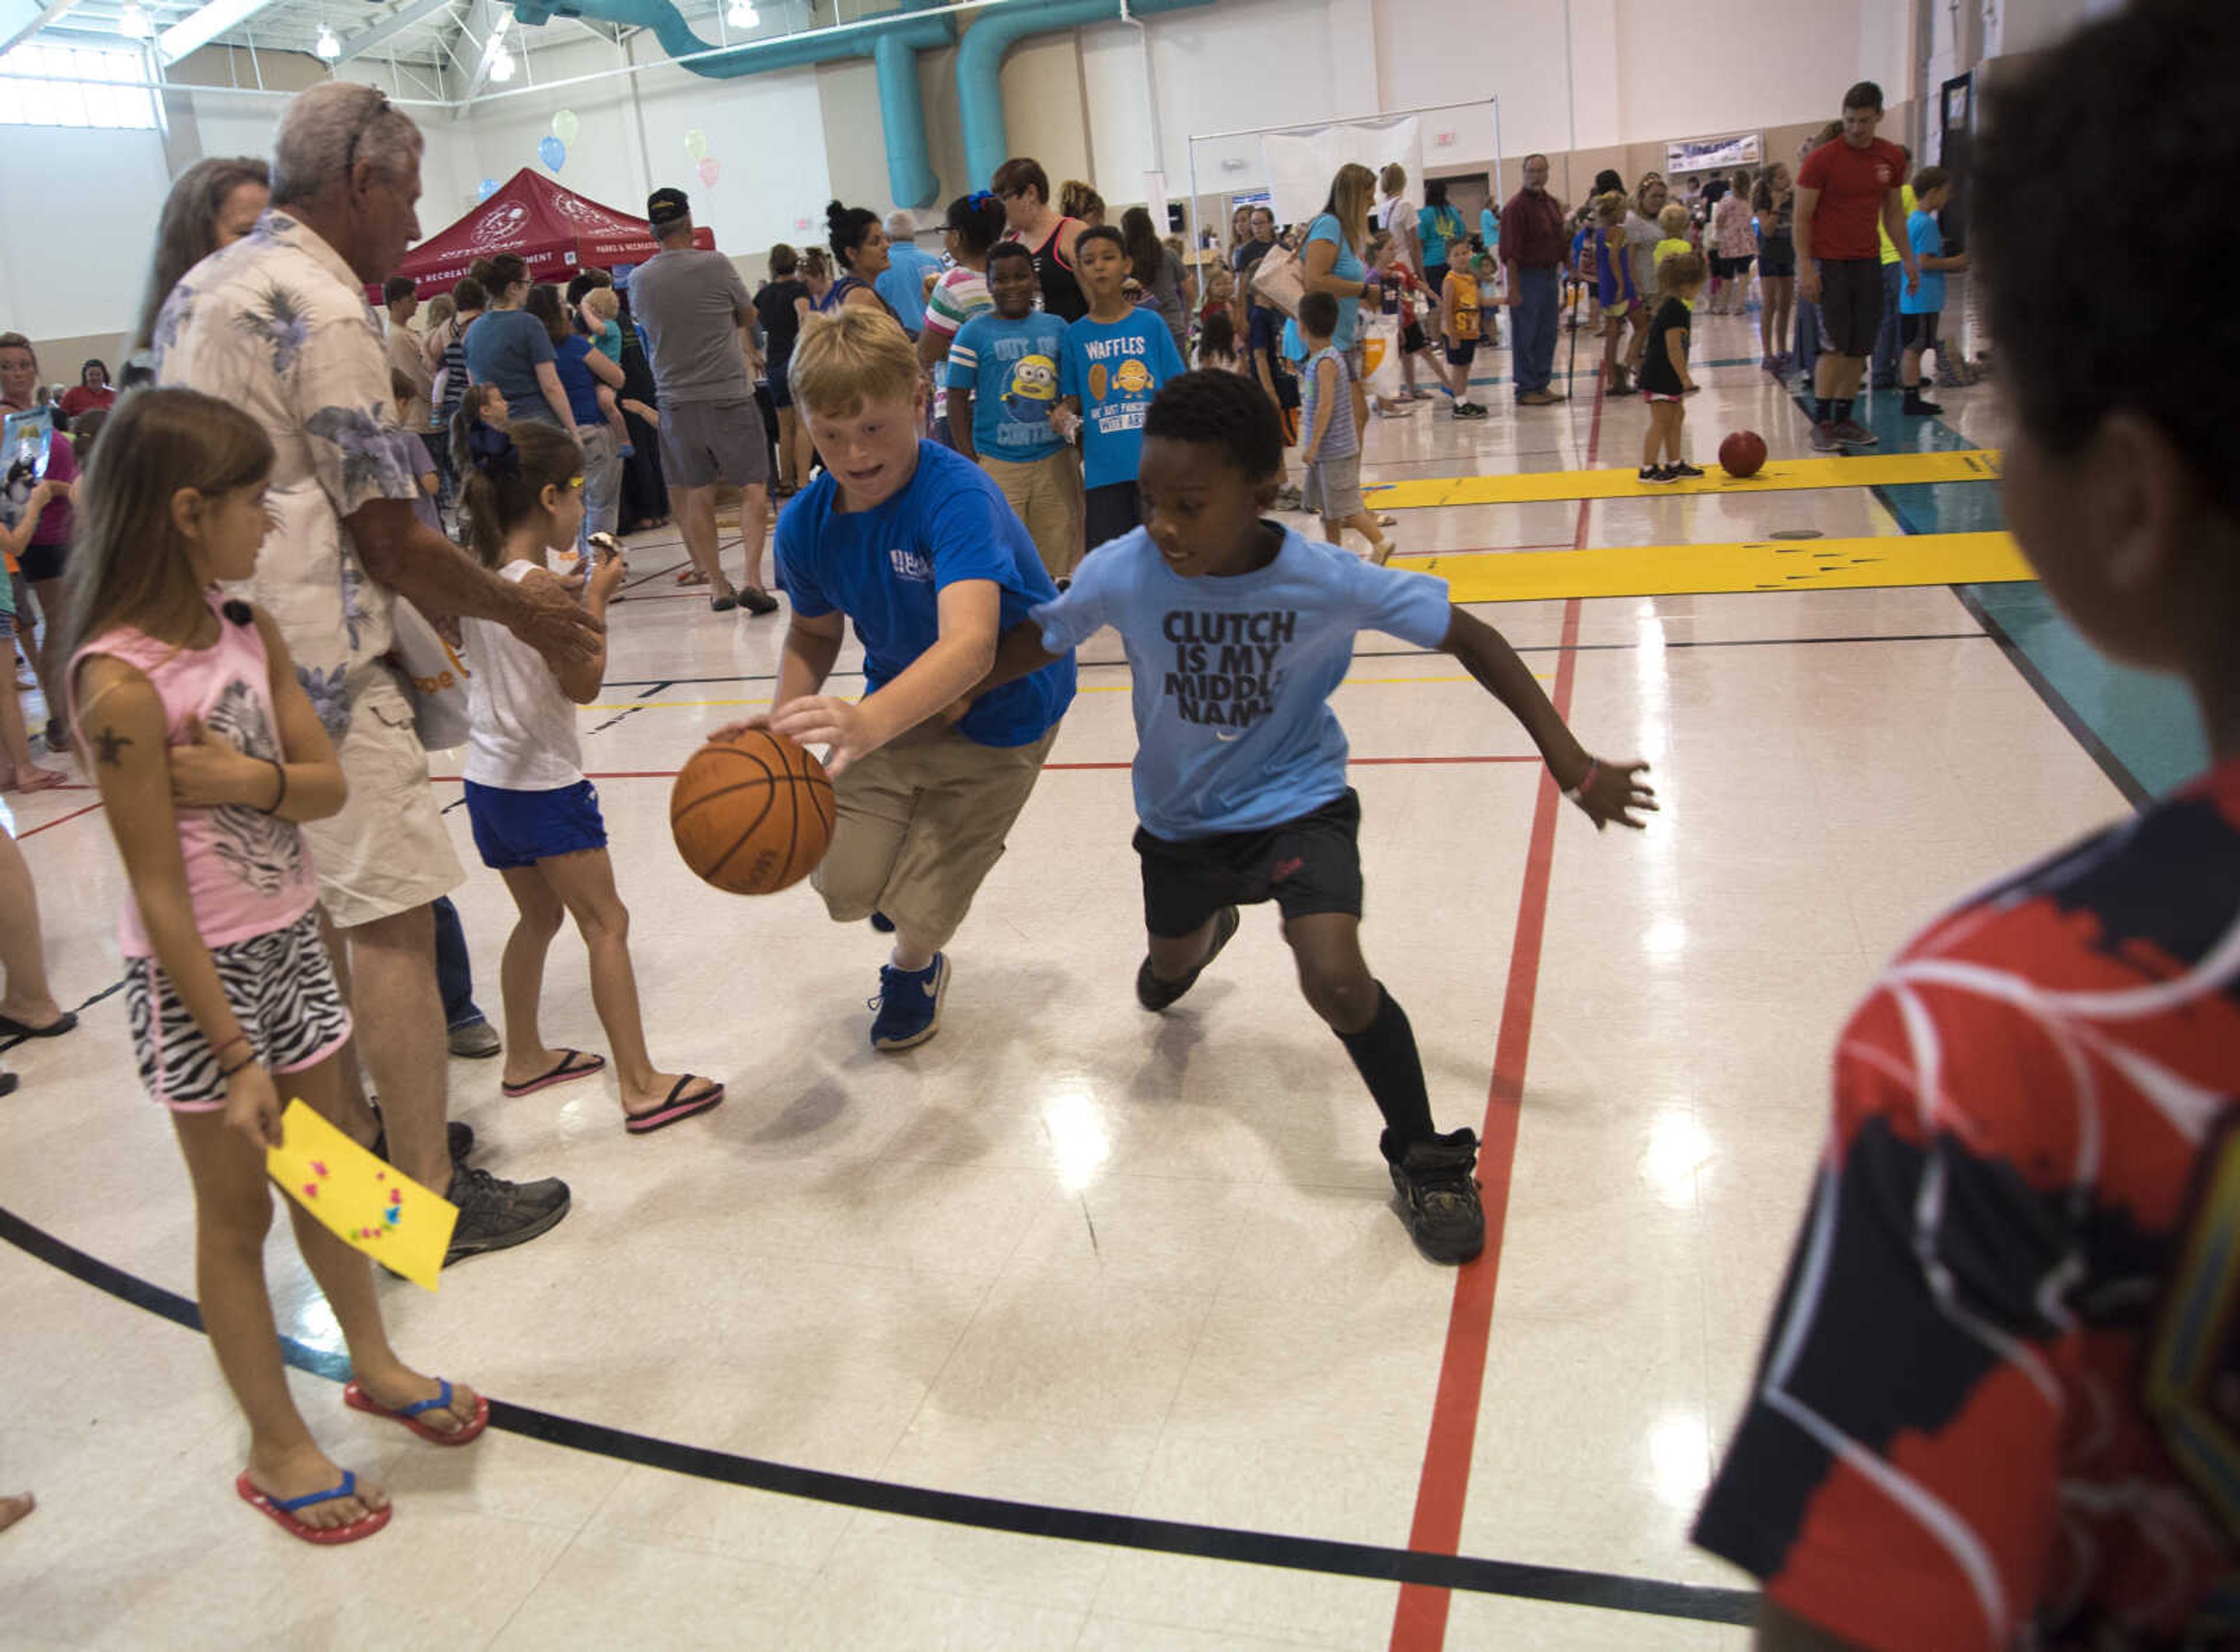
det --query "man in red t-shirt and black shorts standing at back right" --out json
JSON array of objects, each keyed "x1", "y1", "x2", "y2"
[{"x1": 1797, "y1": 80, "x2": 1922, "y2": 452}]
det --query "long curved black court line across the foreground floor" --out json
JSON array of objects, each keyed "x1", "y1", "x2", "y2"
[{"x1": 0, "y1": 1206, "x2": 1758, "y2": 1623}]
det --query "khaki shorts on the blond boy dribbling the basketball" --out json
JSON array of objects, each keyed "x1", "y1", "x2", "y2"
[{"x1": 811, "y1": 725, "x2": 1057, "y2": 947}]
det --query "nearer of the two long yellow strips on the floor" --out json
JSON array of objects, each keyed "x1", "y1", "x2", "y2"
[{"x1": 1391, "y1": 533, "x2": 2036, "y2": 602}]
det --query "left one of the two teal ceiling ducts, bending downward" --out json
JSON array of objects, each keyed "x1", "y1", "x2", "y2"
[{"x1": 513, "y1": 0, "x2": 954, "y2": 208}]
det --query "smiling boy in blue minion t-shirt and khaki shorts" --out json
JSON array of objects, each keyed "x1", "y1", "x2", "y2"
[{"x1": 947, "y1": 242, "x2": 1082, "y2": 589}]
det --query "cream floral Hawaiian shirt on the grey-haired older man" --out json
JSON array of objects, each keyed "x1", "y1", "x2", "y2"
[{"x1": 155, "y1": 211, "x2": 419, "y2": 743}]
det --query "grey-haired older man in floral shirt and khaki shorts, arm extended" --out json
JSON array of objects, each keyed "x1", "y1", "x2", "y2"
[{"x1": 155, "y1": 83, "x2": 598, "y2": 1260}]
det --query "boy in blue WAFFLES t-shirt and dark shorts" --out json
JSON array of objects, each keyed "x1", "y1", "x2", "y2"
[{"x1": 1057, "y1": 226, "x2": 1185, "y2": 551}]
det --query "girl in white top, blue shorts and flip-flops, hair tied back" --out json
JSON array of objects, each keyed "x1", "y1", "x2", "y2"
[{"x1": 457, "y1": 412, "x2": 723, "y2": 1135}]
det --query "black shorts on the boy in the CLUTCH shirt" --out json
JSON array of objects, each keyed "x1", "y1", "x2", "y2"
[{"x1": 1136, "y1": 788, "x2": 1362, "y2": 940}]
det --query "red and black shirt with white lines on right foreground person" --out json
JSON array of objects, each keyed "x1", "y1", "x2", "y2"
[{"x1": 1693, "y1": 759, "x2": 2240, "y2": 1652}]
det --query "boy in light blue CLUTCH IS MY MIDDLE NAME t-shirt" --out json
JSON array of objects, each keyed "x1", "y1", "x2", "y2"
[{"x1": 981, "y1": 372, "x2": 1656, "y2": 1262}]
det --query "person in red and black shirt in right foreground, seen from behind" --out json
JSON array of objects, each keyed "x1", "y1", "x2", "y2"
[{"x1": 1693, "y1": 0, "x2": 2240, "y2": 1652}]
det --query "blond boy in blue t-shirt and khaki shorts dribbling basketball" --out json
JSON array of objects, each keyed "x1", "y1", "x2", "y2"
[{"x1": 717, "y1": 307, "x2": 1073, "y2": 1050}]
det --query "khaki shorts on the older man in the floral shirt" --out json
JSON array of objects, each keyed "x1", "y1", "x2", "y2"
[{"x1": 302, "y1": 667, "x2": 466, "y2": 929}]
